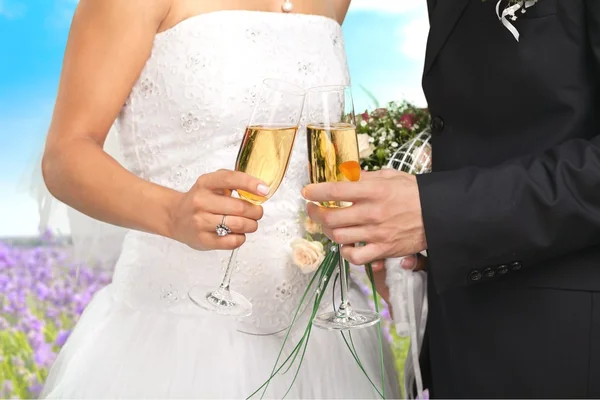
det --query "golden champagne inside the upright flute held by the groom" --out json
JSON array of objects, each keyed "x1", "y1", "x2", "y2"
[{"x1": 306, "y1": 123, "x2": 360, "y2": 207}]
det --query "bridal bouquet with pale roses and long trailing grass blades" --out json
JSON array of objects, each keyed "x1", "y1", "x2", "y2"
[{"x1": 250, "y1": 102, "x2": 430, "y2": 398}]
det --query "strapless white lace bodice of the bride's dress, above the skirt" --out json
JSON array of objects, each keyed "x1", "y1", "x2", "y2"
[{"x1": 113, "y1": 11, "x2": 349, "y2": 333}]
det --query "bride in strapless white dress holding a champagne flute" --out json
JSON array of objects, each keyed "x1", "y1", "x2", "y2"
[{"x1": 42, "y1": 0, "x2": 398, "y2": 399}]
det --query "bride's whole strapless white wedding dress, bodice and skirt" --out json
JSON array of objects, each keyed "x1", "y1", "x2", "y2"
[{"x1": 42, "y1": 11, "x2": 399, "y2": 399}]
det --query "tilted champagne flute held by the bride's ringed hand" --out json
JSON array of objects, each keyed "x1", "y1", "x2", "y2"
[{"x1": 188, "y1": 79, "x2": 306, "y2": 317}]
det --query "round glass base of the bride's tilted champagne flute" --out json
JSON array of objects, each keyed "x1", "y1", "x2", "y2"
[{"x1": 188, "y1": 285, "x2": 252, "y2": 317}]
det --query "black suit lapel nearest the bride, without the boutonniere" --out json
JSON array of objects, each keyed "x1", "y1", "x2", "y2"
[{"x1": 424, "y1": 0, "x2": 469, "y2": 74}]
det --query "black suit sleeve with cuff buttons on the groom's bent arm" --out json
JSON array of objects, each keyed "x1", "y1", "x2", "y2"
[{"x1": 417, "y1": 0, "x2": 600, "y2": 293}]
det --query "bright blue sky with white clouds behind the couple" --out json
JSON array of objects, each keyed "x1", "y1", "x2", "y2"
[{"x1": 0, "y1": 0, "x2": 428, "y2": 237}]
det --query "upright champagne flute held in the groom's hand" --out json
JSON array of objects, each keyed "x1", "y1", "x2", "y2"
[{"x1": 306, "y1": 86, "x2": 379, "y2": 330}]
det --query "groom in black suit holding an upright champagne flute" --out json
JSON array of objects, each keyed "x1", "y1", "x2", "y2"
[{"x1": 304, "y1": 0, "x2": 600, "y2": 398}]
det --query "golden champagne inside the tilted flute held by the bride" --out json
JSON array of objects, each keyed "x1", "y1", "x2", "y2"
[{"x1": 235, "y1": 126, "x2": 298, "y2": 204}]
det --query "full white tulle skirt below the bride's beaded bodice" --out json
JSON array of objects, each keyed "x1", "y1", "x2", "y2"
[{"x1": 42, "y1": 286, "x2": 399, "y2": 399}]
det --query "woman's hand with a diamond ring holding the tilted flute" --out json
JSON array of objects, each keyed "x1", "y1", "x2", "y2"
[{"x1": 170, "y1": 170, "x2": 269, "y2": 250}]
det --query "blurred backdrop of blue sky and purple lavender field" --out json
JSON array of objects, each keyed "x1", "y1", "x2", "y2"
[{"x1": 0, "y1": 0, "x2": 429, "y2": 398}]
